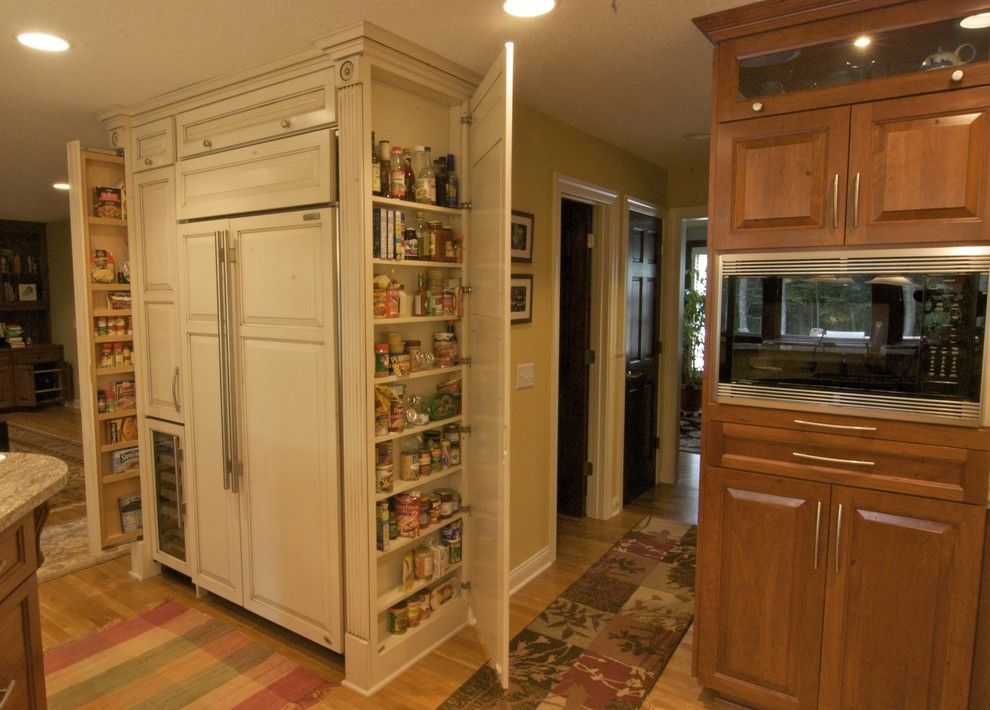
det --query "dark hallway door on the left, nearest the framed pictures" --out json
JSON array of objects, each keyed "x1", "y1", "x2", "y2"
[{"x1": 557, "y1": 200, "x2": 593, "y2": 517}]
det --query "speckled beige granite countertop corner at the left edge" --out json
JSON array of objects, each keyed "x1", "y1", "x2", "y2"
[{"x1": 0, "y1": 452, "x2": 68, "y2": 531}]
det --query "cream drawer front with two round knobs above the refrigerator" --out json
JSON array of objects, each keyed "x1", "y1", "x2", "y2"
[{"x1": 176, "y1": 70, "x2": 336, "y2": 159}]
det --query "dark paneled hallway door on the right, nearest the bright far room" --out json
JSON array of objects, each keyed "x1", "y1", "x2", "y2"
[{"x1": 622, "y1": 212, "x2": 660, "y2": 503}]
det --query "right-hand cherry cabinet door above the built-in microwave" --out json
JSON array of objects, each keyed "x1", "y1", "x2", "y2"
[{"x1": 846, "y1": 88, "x2": 990, "y2": 244}]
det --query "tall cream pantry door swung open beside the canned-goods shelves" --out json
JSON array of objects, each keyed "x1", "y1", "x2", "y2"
[{"x1": 467, "y1": 42, "x2": 513, "y2": 687}]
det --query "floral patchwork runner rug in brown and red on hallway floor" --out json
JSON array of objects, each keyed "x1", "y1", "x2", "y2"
[{"x1": 440, "y1": 517, "x2": 696, "y2": 710}]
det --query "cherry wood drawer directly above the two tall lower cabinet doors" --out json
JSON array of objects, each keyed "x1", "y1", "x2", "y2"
[{"x1": 707, "y1": 422, "x2": 990, "y2": 503}]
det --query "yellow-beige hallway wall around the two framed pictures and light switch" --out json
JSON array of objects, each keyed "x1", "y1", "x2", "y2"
[{"x1": 509, "y1": 104, "x2": 667, "y2": 569}]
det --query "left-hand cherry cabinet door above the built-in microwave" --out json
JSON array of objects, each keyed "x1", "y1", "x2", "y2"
[{"x1": 710, "y1": 108, "x2": 849, "y2": 249}]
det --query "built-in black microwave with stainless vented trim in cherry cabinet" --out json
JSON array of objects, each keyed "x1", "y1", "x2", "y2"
[{"x1": 714, "y1": 247, "x2": 990, "y2": 426}]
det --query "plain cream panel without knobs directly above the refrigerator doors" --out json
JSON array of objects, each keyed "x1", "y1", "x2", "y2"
[{"x1": 176, "y1": 130, "x2": 337, "y2": 220}]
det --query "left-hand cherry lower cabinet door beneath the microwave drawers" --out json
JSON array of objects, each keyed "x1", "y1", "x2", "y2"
[{"x1": 696, "y1": 467, "x2": 836, "y2": 709}]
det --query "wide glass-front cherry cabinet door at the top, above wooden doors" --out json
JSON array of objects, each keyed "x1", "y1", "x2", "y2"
[{"x1": 718, "y1": 0, "x2": 990, "y2": 120}]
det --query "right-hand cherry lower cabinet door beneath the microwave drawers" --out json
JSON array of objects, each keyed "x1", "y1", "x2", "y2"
[{"x1": 816, "y1": 486, "x2": 986, "y2": 710}]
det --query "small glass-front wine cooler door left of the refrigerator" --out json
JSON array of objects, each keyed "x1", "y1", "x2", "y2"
[{"x1": 148, "y1": 420, "x2": 188, "y2": 571}]
